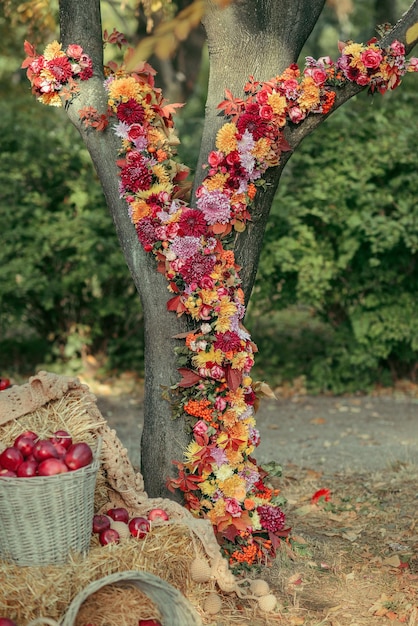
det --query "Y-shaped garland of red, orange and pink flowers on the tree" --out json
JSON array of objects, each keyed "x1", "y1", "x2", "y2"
[{"x1": 23, "y1": 38, "x2": 418, "y2": 570}]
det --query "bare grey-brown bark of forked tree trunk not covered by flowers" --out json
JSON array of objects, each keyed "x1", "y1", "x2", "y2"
[{"x1": 23, "y1": 0, "x2": 418, "y2": 502}]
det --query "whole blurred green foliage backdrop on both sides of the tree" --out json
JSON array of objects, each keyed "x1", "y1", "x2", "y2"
[{"x1": 0, "y1": 3, "x2": 418, "y2": 393}]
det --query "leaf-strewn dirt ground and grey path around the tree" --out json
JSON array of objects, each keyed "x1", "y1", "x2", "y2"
[{"x1": 86, "y1": 374, "x2": 418, "y2": 626}]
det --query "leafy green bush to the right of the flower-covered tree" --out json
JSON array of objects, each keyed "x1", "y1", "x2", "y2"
[{"x1": 252, "y1": 77, "x2": 418, "y2": 392}]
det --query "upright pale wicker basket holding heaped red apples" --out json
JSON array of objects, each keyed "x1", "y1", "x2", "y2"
[{"x1": 0, "y1": 438, "x2": 101, "y2": 566}]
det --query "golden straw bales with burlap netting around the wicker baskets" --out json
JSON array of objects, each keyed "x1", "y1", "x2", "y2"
[{"x1": 0, "y1": 372, "x2": 280, "y2": 626}]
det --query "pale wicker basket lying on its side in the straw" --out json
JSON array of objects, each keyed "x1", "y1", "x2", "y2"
[{"x1": 60, "y1": 570, "x2": 202, "y2": 626}]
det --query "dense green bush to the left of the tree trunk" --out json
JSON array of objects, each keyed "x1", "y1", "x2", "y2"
[{"x1": 0, "y1": 88, "x2": 143, "y2": 371}]
